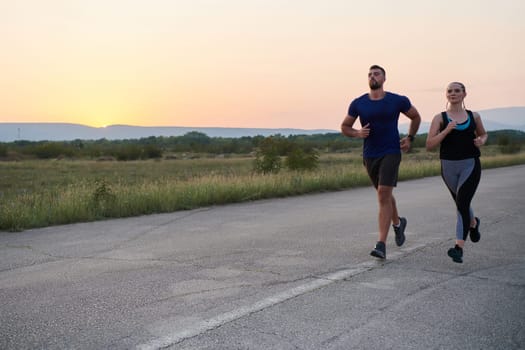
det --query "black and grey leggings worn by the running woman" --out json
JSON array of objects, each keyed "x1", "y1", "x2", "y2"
[{"x1": 441, "y1": 158, "x2": 481, "y2": 240}]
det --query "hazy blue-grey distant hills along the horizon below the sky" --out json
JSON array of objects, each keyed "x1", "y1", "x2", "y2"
[{"x1": 0, "y1": 107, "x2": 525, "y2": 142}]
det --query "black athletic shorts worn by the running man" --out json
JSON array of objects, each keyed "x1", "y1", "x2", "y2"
[{"x1": 363, "y1": 153, "x2": 401, "y2": 189}]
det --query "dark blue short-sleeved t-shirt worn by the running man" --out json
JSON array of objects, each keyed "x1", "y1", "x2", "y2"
[{"x1": 348, "y1": 92, "x2": 412, "y2": 158}]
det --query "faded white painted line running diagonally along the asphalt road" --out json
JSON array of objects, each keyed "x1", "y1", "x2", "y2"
[{"x1": 137, "y1": 244, "x2": 438, "y2": 350}]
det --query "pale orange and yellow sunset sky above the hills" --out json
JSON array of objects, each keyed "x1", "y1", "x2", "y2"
[{"x1": 0, "y1": 0, "x2": 525, "y2": 129}]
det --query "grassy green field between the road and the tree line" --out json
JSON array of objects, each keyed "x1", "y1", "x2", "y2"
[{"x1": 0, "y1": 147, "x2": 525, "y2": 231}]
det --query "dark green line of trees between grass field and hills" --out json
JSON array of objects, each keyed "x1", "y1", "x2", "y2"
[{"x1": 0, "y1": 130, "x2": 525, "y2": 161}]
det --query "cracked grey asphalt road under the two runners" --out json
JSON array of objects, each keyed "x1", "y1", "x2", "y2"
[{"x1": 0, "y1": 166, "x2": 525, "y2": 350}]
